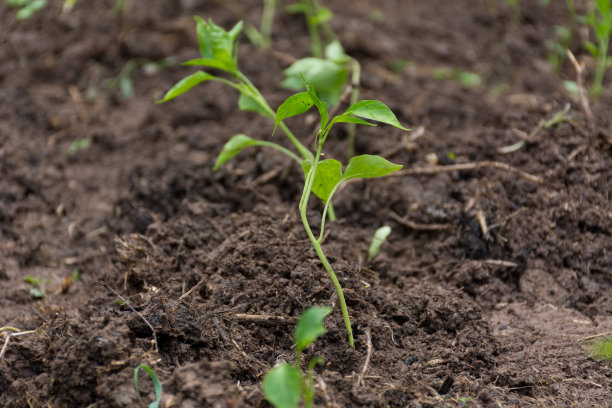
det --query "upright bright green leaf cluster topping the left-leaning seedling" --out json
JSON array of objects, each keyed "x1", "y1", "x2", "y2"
[{"x1": 195, "y1": 16, "x2": 242, "y2": 73}]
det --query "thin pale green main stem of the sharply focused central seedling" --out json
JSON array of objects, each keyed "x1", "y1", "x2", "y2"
[{"x1": 299, "y1": 138, "x2": 355, "y2": 348}]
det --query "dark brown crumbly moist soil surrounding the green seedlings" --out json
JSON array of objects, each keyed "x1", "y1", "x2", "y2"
[{"x1": 0, "y1": 0, "x2": 612, "y2": 407}]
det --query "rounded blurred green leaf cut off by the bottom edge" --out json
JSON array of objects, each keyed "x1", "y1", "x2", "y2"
[{"x1": 262, "y1": 363, "x2": 304, "y2": 408}]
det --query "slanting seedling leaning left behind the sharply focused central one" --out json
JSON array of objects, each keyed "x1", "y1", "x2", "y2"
[{"x1": 159, "y1": 17, "x2": 312, "y2": 166}]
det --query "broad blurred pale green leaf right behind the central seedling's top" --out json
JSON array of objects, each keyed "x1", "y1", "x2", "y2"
[{"x1": 281, "y1": 57, "x2": 348, "y2": 106}]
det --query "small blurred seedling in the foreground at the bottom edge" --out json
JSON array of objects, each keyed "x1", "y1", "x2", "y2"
[{"x1": 262, "y1": 306, "x2": 332, "y2": 408}]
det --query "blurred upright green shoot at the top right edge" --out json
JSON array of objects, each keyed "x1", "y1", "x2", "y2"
[{"x1": 584, "y1": 0, "x2": 612, "y2": 101}]
